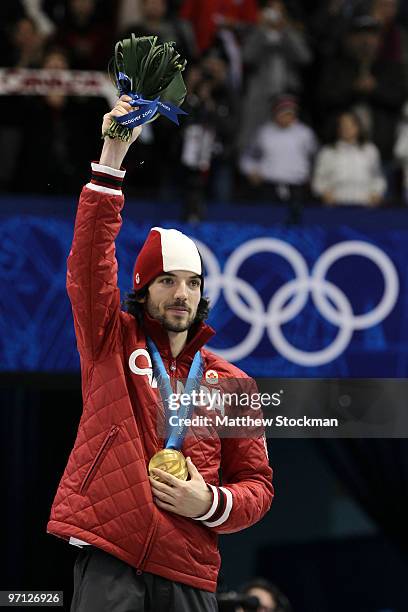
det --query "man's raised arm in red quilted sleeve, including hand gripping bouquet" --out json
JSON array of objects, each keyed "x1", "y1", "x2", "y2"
[{"x1": 67, "y1": 96, "x2": 142, "y2": 360}]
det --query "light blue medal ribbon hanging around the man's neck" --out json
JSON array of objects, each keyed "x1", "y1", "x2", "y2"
[{"x1": 147, "y1": 338, "x2": 203, "y2": 450}]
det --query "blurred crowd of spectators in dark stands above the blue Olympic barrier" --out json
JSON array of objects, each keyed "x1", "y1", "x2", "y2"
[{"x1": 0, "y1": 0, "x2": 408, "y2": 222}]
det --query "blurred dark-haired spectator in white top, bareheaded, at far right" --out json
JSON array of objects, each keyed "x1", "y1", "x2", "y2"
[{"x1": 312, "y1": 112, "x2": 386, "y2": 206}]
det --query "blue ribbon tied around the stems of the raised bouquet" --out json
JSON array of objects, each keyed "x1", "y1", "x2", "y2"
[{"x1": 115, "y1": 72, "x2": 188, "y2": 130}]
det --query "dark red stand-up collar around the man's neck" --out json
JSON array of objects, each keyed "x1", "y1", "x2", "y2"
[{"x1": 143, "y1": 311, "x2": 215, "y2": 362}]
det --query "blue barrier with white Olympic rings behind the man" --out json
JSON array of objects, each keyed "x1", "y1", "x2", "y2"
[{"x1": 0, "y1": 211, "x2": 408, "y2": 377}]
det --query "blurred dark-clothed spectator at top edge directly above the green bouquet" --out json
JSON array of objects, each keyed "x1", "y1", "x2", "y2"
[{"x1": 122, "y1": 0, "x2": 198, "y2": 62}]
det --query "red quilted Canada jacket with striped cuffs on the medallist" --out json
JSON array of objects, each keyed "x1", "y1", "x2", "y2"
[{"x1": 47, "y1": 164, "x2": 273, "y2": 591}]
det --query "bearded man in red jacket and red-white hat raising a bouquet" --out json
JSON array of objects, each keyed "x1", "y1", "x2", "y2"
[{"x1": 47, "y1": 96, "x2": 273, "y2": 612}]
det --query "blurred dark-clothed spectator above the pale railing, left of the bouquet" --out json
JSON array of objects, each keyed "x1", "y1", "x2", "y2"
[{"x1": 54, "y1": 0, "x2": 115, "y2": 70}]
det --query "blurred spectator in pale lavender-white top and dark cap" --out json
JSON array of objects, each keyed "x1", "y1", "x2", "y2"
[{"x1": 240, "y1": 95, "x2": 317, "y2": 223}]
